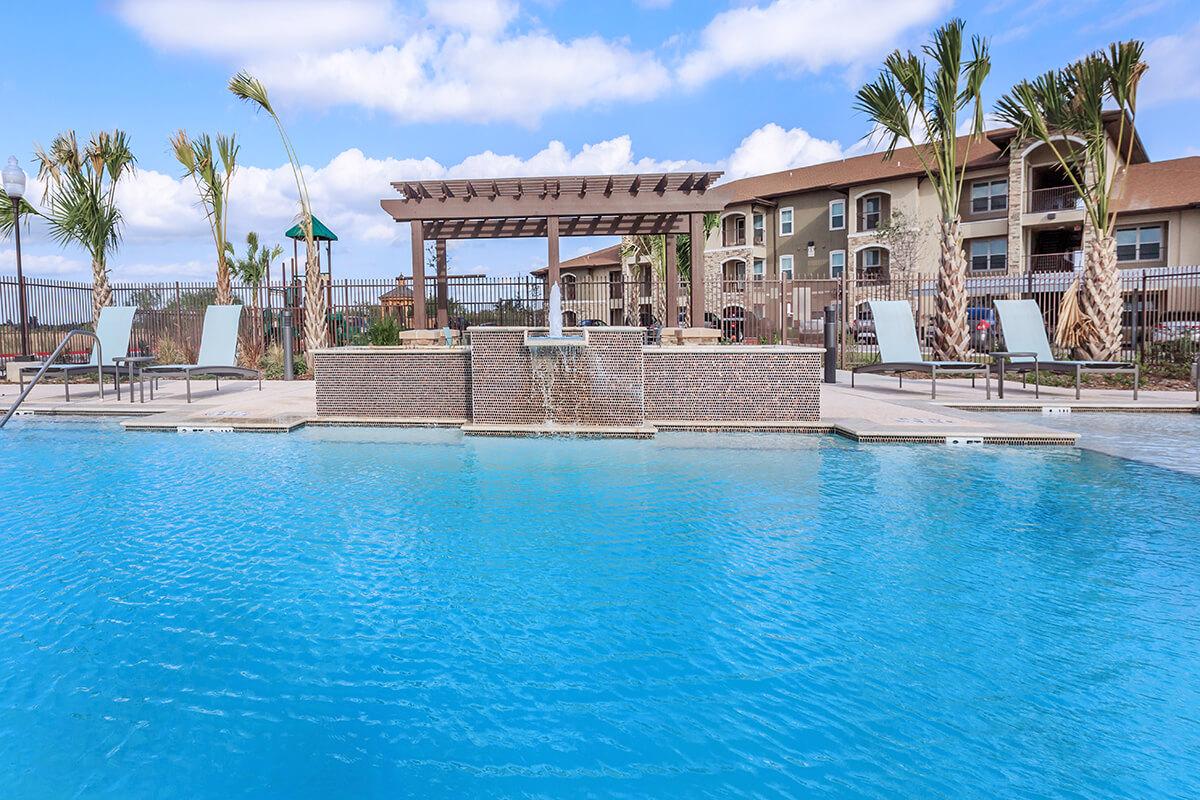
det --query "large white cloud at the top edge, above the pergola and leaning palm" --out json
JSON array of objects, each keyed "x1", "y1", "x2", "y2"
[{"x1": 118, "y1": 0, "x2": 671, "y2": 125}]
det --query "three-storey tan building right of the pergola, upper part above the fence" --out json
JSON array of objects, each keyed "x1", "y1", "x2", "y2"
[{"x1": 707, "y1": 112, "x2": 1200, "y2": 281}]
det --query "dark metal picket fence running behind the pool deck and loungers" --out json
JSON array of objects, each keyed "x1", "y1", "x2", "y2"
[{"x1": 0, "y1": 267, "x2": 1200, "y2": 365}]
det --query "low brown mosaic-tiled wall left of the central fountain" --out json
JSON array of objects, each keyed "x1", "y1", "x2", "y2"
[{"x1": 312, "y1": 347, "x2": 470, "y2": 421}]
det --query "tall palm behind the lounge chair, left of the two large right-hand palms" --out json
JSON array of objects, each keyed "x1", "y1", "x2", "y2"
[{"x1": 857, "y1": 19, "x2": 991, "y2": 360}]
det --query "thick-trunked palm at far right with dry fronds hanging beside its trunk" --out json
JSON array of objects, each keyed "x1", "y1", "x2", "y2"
[{"x1": 996, "y1": 41, "x2": 1146, "y2": 361}]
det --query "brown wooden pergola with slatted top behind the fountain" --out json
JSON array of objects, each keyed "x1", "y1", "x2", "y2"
[{"x1": 379, "y1": 172, "x2": 727, "y2": 329}]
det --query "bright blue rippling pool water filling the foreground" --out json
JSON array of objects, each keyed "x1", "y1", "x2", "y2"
[{"x1": 0, "y1": 420, "x2": 1200, "y2": 798}]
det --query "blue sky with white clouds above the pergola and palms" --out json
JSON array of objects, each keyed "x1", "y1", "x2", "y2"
[{"x1": 0, "y1": 0, "x2": 1200, "y2": 282}]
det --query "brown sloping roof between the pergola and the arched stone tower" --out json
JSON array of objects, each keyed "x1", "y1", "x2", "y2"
[{"x1": 722, "y1": 137, "x2": 1004, "y2": 203}]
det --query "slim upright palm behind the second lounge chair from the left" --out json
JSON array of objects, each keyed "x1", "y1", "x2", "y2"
[{"x1": 170, "y1": 131, "x2": 239, "y2": 306}]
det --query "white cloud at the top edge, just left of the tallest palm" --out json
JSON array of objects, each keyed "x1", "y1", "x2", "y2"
[{"x1": 678, "y1": 0, "x2": 950, "y2": 86}]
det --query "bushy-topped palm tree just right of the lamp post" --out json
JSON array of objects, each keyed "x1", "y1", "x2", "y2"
[{"x1": 22, "y1": 131, "x2": 137, "y2": 320}]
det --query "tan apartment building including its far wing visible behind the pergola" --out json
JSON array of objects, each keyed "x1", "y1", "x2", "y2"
[{"x1": 534, "y1": 113, "x2": 1200, "y2": 337}]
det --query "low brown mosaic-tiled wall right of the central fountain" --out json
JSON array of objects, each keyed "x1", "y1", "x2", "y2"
[{"x1": 644, "y1": 345, "x2": 821, "y2": 423}]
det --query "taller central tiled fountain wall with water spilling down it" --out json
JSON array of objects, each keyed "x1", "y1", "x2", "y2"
[{"x1": 468, "y1": 327, "x2": 646, "y2": 427}]
